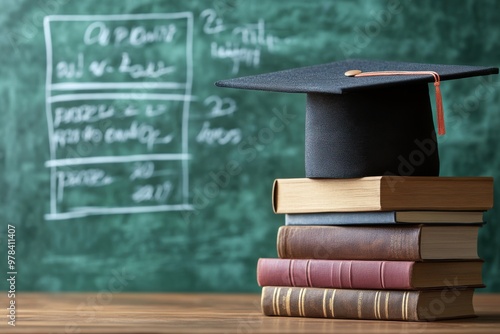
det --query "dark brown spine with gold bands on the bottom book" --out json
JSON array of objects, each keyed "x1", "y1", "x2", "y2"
[{"x1": 261, "y1": 286, "x2": 419, "y2": 321}]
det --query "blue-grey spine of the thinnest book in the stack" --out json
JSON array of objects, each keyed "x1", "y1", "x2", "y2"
[{"x1": 285, "y1": 211, "x2": 396, "y2": 225}]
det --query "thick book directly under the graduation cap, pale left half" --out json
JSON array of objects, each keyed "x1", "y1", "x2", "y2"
[{"x1": 272, "y1": 176, "x2": 493, "y2": 213}]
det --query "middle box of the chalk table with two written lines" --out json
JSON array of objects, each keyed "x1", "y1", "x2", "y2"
[{"x1": 49, "y1": 94, "x2": 184, "y2": 160}]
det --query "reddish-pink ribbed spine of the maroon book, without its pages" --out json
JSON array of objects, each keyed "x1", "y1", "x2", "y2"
[{"x1": 257, "y1": 259, "x2": 414, "y2": 290}]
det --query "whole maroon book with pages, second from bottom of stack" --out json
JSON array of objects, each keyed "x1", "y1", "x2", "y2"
[{"x1": 257, "y1": 258, "x2": 483, "y2": 290}]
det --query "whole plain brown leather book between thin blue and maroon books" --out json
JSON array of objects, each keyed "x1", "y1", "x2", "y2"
[{"x1": 277, "y1": 225, "x2": 480, "y2": 261}]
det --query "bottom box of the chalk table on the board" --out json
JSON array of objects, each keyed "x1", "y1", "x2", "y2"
[{"x1": 49, "y1": 159, "x2": 189, "y2": 218}]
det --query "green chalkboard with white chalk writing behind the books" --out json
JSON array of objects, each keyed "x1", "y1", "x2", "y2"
[{"x1": 0, "y1": 0, "x2": 500, "y2": 291}]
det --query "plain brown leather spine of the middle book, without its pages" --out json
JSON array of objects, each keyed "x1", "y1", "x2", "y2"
[{"x1": 277, "y1": 225, "x2": 421, "y2": 261}]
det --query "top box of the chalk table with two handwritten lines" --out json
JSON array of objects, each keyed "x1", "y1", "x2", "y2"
[{"x1": 44, "y1": 12, "x2": 193, "y2": 90}]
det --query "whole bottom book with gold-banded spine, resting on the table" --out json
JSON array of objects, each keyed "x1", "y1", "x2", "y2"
[{"x1": 261, "y1": 286, "x2": 475, "y2": 321}]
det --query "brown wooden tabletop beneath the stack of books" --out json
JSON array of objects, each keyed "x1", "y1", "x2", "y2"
[{"x1": 0, "y1": 292, "x2": 500, "y2": 334}]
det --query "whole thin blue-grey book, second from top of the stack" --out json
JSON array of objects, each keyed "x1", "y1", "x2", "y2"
[{"x1": 285, "y1": 211, "x2": 483, "y2": 225}]
